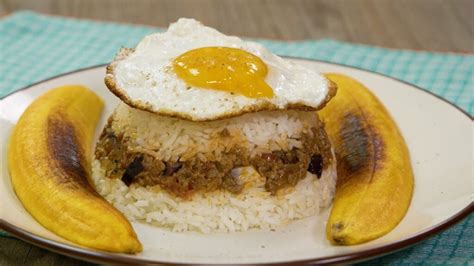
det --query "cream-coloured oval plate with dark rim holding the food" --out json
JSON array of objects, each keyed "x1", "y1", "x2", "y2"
[{"x1": 0, "y1": 58, "x2": 473, "y2": 263}]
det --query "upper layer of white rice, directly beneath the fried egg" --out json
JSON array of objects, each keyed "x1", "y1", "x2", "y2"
[{"x1": 110, "y1": 103, "x2": 321, "y2": 161}]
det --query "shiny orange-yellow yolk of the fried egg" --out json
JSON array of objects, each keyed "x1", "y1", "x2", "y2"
[{"x1": 173, "y1": 47, "x2": 273, "y2": 98}]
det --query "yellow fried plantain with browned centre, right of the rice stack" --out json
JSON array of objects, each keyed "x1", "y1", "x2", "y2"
[{"x1": 319, "y1": 74, "x2": 413, "y2": 245}]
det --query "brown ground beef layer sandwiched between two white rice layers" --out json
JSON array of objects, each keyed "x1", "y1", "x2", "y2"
[{"x1": 95, "y1": 124, "x2": 332, "y2": 197}]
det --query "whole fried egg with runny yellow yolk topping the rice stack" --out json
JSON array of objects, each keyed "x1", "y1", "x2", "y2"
[{"x1": 105, "y1": 18, "x2": 335, "y2": 121}]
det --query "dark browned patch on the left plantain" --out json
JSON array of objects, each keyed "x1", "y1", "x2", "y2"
[{"x1": 47, "y1": 114, "x2": 96, "y2": 193}]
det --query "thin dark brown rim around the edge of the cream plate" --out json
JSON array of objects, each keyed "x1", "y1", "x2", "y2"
[{"x1": 0, "y1": 56, "x2": 474, "y2": 265}]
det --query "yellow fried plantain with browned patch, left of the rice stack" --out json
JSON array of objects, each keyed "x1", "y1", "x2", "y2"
[{"x1": 8, "y1": 86, "x2": 142, "y2": 253}]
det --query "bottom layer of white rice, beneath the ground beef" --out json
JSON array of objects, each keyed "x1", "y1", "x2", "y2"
[{"x1": 93, "y1": 160, "x2": 336, "y2": 233}]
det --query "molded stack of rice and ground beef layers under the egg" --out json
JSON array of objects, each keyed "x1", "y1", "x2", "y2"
[{"x1": 94, "y1": 104, "x2": 336, "y2": 233}]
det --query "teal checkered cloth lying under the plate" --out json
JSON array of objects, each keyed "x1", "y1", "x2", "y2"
[{"x1": 0, "y1": 12, "x2": 474, "y2": 265}]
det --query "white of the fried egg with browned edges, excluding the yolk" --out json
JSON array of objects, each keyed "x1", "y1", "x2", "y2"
[{"x1": 106, "y1": 18, "x2": 329, "y2": 121}]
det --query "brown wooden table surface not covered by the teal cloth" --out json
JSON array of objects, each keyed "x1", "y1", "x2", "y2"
[{"x1": 0, "y1": 0, "x2": 474, "y2": 265}]
